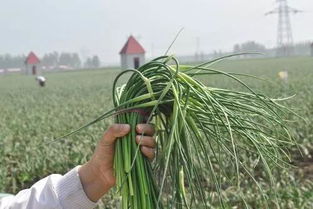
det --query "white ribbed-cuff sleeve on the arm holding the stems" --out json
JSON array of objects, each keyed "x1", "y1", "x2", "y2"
[{"x1": 0, "y1": 167, "x2": 97, "y2": 209}]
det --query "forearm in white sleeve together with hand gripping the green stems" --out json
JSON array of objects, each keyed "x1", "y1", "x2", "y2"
[{"x1": 0, "y1": 124, "x2": 156, "y2": 209}]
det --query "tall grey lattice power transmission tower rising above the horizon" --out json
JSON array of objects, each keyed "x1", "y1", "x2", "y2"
[{"x1": 265, "y1": 0, "x2": 302, "y2": 56}]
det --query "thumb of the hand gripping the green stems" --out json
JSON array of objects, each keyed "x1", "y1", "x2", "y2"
[{"x1": 101, "y1": 124, "x2": 130, "y2": 145}]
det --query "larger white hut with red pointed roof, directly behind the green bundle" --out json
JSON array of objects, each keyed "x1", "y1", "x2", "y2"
[{"x1": 120, "y1": 35, "x2": 145, "y2": 70}]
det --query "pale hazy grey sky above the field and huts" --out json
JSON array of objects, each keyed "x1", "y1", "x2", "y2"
[{"x1": 0, "y1": 0, "x2": 313, "y2": 63}]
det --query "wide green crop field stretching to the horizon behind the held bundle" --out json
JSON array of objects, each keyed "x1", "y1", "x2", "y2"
[{"x1": 0, "y1": 57, "x2": 313, "y2": 208}]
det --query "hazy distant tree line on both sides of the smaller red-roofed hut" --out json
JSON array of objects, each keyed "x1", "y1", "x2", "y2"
[{"x1": 0, "y1": 52, "x2": 101, "y2": 69}]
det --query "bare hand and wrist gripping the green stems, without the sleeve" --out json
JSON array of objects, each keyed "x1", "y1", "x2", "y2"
[{"x1": 78, "y1": 124, "x2": 156, "y2": 202}]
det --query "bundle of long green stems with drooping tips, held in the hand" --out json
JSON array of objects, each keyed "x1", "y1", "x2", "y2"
[{"x1": 62, "y1": 56, "x2": 294, "y2": 209}]
